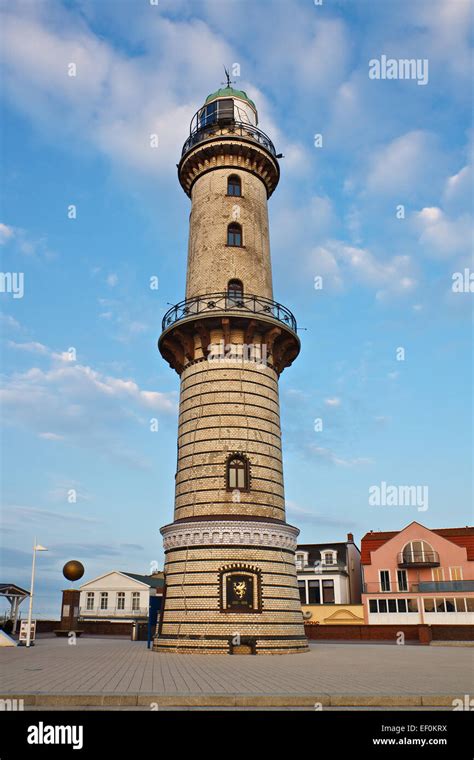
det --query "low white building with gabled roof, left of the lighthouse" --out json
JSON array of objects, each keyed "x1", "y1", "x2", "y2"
[{"x1": 79, "y1": 570, "x2": 163, "y2": 622}]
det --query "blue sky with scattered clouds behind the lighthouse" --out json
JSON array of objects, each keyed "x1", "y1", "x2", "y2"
[{"x1": 0, "y1": 0, "x2": 474, "y2": 618}]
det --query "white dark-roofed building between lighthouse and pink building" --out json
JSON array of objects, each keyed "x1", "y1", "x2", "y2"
[{"x1": 296, "y1": 533, "x2": 361, "y2": 605}]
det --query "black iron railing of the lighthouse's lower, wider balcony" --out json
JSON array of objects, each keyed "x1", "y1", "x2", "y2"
[{"x1": 162, "y1": 293, "x2": 296, "y2": 332}]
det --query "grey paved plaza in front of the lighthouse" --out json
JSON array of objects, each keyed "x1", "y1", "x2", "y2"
[{"x1": 0, "y1": 637, "x2": 474, "y2": 709}]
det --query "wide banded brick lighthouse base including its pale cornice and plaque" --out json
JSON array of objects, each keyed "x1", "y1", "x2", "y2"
[{"x1": 153, "y1": 516, "x2": 308, "y2": 654}]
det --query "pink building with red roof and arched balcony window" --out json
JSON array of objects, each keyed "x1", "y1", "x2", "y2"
[{"x1": 361, "y1": 522, "x2": 474, "y2": 625}]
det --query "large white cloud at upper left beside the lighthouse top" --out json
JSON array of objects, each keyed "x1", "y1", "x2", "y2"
[{"x1": 0, "y1": 4, "x2": 231, "y2": 173}]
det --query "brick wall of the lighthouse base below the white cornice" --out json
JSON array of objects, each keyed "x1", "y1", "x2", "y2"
[{"x1": 155, "y1": 546, "x2": 306, "y2": 652}]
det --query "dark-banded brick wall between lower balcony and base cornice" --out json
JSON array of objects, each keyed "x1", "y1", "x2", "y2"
[{"x1": 175, "y1": 361, "x2": 285, "y2": 520}]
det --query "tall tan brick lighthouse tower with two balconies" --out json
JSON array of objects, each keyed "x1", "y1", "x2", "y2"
[{"x1": 154, "y1": 82, "x2": 307, "y2": 654}]
